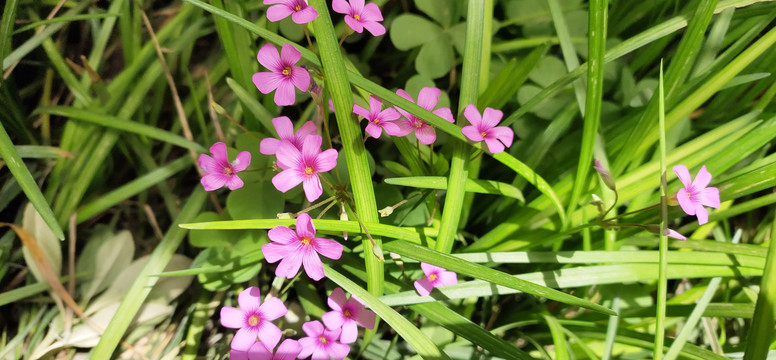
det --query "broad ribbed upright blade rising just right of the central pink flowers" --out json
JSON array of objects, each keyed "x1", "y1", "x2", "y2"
[{"x1": 310, "y1": 0, "x2": 384, "y2": 296}]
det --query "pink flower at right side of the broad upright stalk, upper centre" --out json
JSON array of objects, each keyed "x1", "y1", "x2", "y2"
[{"x1": 461, "y1": 104, "x2": 515, "y2": 154}]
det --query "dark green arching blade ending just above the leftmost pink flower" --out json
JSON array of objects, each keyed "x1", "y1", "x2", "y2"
[{"x1": 35, "y1": 106, "x2": 207, "y2": 153}]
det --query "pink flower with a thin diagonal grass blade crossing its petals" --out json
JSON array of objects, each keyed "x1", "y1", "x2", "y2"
[{"x1": 395, "y1": 87, "x2": 455, "y2": 145}]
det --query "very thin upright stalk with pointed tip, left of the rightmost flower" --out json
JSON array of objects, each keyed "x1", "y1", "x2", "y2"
[{"x1": 652, "y1": 61, "x2": 668, "y2": 360}]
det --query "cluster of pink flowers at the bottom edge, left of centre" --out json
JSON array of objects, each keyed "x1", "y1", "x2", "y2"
[{"x1": 221, "y1": 287, "x2": 377, "y2": 360}]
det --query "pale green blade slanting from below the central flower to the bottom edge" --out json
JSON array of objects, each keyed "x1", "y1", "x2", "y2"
[{"x1": 323, "y1": 264, "x2": 450, "y2": 360}]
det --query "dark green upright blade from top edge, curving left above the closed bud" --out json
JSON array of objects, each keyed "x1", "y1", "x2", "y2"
[{"x1": 559, "y1": 0, "x2": 609, "y2": 219}]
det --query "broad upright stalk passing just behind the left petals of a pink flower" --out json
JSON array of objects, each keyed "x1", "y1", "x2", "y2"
[{"x1": 436, "y1": 0, "x2": 482, "y2": 253}]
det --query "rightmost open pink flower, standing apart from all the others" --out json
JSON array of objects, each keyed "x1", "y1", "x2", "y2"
[{"x1": 674, "y1": 165, "x2": 719, "y2": 225}]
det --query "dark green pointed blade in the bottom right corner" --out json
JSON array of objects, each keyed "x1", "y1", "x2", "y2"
[{"x1": 744, "y1": 219, "x2": 776, "y2": 360}]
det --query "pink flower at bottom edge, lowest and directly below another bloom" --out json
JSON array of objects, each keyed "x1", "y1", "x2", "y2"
[{"x1": 299, "y1": 320, "x2": 350, "y2": 360}]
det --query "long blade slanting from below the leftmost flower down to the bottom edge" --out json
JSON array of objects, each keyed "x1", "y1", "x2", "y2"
[{"x1": 91, "y1": 187, "x2": 206, "y2": 359}]
